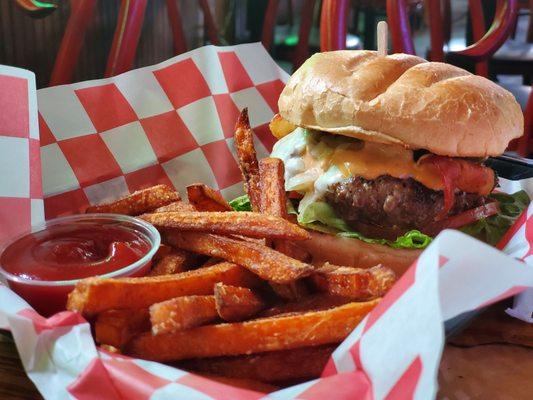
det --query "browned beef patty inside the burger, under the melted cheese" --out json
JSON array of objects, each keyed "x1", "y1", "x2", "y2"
[{"x1": 326, "y1": 175, "x2": 487, "y2": 238}]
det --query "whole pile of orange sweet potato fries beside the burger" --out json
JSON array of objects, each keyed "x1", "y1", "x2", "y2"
[{"x1": 67, "y1": 110, "x2": 395, "y2": 390}]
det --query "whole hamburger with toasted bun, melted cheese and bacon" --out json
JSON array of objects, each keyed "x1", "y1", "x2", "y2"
[{"x1": 270, "y1": 51, "x2": 523, "y2": 269}]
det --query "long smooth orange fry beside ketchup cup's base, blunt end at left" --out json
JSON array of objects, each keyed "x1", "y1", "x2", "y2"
[{"x1": 67, "y1": 263, "x2": 261, "y2": 316}]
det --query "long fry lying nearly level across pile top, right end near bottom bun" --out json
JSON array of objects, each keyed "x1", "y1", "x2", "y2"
[{"x1": 141, "y1": 211, "x2": 309, "y2": 240}]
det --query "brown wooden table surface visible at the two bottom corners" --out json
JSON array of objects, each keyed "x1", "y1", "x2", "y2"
[{"x1": 0, "y1": 302, "x2": 533, "y2": 400}]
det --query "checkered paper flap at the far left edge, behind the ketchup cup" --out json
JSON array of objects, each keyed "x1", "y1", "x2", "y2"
[{"x1": 0, "y1": 66, "x2": 43, "y2": 243}]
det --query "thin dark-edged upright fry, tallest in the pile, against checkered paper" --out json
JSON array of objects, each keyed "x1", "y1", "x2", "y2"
[{"x1": 235, "y1": 108, "x2": 260, "y2": 212}]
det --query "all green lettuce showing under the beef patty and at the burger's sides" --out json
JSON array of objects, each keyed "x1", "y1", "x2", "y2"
[{"x1": 229, "y1": 190, "x2": 530, "y2": 249}]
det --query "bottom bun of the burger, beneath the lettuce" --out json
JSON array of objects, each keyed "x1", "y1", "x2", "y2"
[{"x1": 298, "y1": 231, "x2": 422, "y2": 276}]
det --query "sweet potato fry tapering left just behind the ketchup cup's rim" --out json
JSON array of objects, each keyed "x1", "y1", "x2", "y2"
[{"x1": 87, "y1": 185, "x2": 180, "y2": 215}]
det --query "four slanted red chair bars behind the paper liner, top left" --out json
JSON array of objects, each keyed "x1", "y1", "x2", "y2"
[{"x1": 49, "y1": 0, "x2": 218, "y2": 86}]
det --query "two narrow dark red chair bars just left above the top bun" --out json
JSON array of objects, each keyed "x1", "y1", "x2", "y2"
[{"x1": 261, "y1": 0, "x2": 317, "y2": 69}]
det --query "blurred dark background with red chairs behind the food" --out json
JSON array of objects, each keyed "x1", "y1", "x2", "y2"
[{"x1": 0, "y1": 0, "x2": 533, "y2": 154}]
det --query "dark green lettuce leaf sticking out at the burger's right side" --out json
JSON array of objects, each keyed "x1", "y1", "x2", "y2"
[{"x1": 460, "y1": 190, "x2": 531, "y2": 246}]
